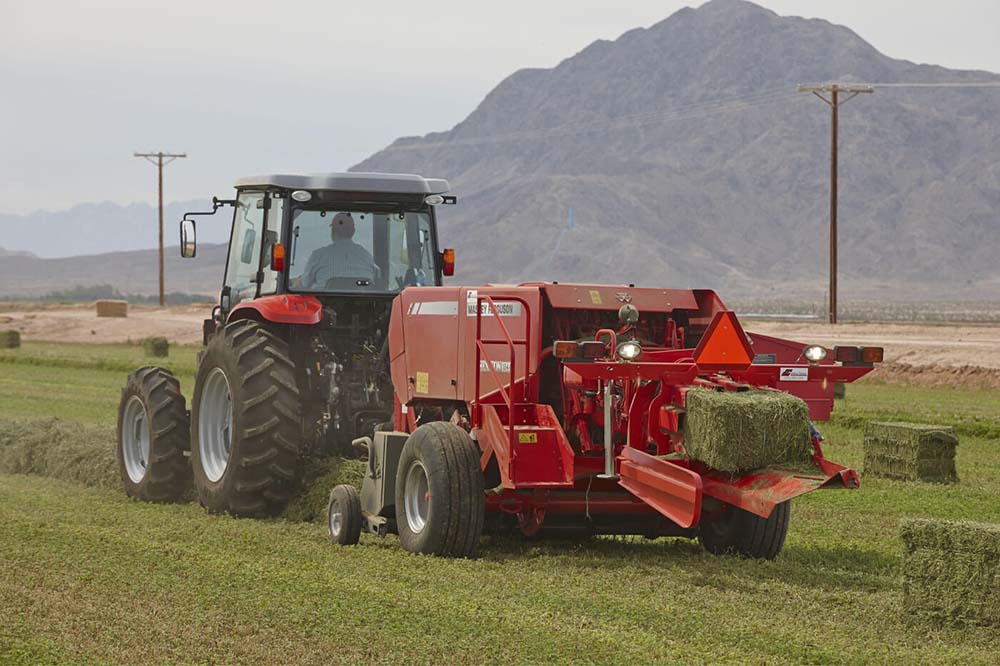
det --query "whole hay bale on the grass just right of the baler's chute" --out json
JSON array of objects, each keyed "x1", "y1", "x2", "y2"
[{"x1": 864, "y1": 422, "x2": 958, "y2": 483}]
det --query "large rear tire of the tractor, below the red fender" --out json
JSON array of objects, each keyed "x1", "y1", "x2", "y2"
[{"x1": 191, "y1": 320, "x2": 302, "y2": 517}]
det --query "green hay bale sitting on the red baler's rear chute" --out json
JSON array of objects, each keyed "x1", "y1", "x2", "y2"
[{"x1": 684, "y1": 389, "x2": 813, "y2": 472}]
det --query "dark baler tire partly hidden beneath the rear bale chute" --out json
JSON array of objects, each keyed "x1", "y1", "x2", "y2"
[{"x1": 698, "y1": 501, "x2": 792, "y2": 560}]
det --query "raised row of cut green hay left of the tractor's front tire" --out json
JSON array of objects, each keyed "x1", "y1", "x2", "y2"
[{"x1": 0, "y1": 418, "x2": 122, "y2": 488}]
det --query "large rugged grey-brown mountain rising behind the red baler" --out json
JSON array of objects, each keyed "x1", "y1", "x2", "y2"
[{"x1": 353, "y1": 0, "x2": 1000, "y2": 300}]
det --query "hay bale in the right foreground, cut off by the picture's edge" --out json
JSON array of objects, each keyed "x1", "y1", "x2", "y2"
[{"x1": 901, "y1": 519, "x2": 1000, "y2": 627}]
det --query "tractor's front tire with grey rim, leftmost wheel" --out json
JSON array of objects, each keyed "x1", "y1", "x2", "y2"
[{"x1": 116, "y1": 366, "x2": 191, "y2": 502}]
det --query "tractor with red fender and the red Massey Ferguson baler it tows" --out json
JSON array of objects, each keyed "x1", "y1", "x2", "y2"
[{"x1": 119, "y1": 174, "x2": 882, "y2": 558}]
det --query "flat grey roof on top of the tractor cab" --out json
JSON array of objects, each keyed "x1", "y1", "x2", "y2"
[{"x1": 236, "y1": 172, "x2": 451, "y2": 194}]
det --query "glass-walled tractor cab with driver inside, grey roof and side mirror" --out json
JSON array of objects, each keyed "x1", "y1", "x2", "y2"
[{"x1": 181, "y1": 173, "x2": 455, "y2": 322}]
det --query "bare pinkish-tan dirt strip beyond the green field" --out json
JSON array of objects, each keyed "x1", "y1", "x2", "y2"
[{"x1": 0, "y1": 303, "x2": 1000, "y2": 388}]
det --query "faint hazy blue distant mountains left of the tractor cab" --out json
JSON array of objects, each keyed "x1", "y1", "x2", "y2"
[{"x1": 0, "y1": 200, "x2": 232, "y2": 258}]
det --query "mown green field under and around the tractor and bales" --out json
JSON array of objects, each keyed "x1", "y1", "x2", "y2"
[{"x1": 0, "y1": 343, "x2": 1000, "y2": 664}]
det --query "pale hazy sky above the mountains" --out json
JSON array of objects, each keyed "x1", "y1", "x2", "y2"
[{"x1": 0, "y1": 0, "x2": 1000, "y2": 213}]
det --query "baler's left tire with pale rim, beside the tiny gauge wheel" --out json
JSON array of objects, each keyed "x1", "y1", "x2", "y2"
[{"x1": 396, "y1": 421, "x2": 486, "y2": 557}]
